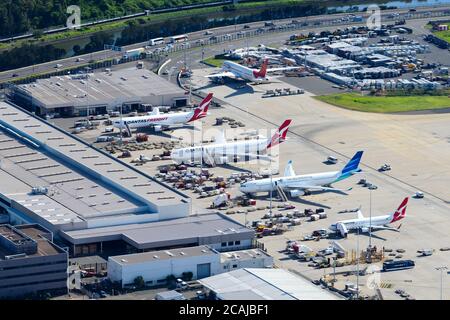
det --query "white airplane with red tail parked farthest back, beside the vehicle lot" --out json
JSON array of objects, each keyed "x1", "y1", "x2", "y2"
[{"x1": 206, "y1": 59, "x2": 298, "y2": 84}]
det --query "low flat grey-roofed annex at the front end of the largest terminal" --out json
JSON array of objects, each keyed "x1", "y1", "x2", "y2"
[{"x1": 61, "y1": 213, "x2": 255, "y2": 256}]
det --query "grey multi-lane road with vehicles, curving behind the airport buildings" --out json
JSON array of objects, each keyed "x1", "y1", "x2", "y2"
[{"x1": 0, "y1": 6, "x2": 450, "y2": 83}]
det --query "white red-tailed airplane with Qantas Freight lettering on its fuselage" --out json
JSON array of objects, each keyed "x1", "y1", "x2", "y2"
[{"x1": 113, "y1": 93, "x2": 213, "y2": 136}]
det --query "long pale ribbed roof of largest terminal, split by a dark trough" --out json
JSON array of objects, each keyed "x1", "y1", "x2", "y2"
[{"x1": 0, "y1": 102, "x2": 190, "y2": 229}]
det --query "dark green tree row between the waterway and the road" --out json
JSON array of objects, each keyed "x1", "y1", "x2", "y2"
[{"x1": 0, "y1": 0, "x2": 326, "y2": 71}]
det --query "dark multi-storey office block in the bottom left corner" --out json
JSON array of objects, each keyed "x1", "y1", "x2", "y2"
[{"x1": 0, "y1": 225, "x2": 68, "y2": 298}]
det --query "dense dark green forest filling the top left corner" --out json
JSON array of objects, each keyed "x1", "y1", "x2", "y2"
[{"x1": 0, "y1": 0, "x2": 218, "y2": 37}]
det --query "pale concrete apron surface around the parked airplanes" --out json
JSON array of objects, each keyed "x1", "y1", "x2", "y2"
[{"x1": 183, "y1": 70, "x2": 450, "y2": 299}]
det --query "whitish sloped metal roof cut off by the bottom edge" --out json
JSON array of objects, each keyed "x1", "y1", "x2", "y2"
[{"x1": 199, "y1": 268, "x2": 341, "y2": 300}]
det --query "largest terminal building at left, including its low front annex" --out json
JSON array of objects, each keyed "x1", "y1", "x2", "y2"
[{"x1": 0, "y1": 102, "x2": 254, "y2": 256}]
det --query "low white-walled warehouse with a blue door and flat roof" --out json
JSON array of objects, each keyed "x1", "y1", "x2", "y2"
[{"x1": 108, "y1": 246, "x2": 273, "y2": 287}]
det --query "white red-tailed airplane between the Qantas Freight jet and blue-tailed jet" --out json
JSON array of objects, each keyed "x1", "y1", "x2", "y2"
[{"x1": 171, "y1": 120, "x2": 292, "y2": 166}]
